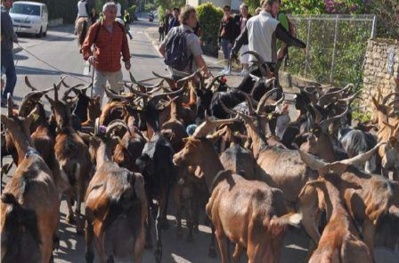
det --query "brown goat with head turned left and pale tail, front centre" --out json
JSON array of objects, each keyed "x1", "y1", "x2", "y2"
[{"x1": 173, "y1": 133, "x2": 299, "y2": 262}]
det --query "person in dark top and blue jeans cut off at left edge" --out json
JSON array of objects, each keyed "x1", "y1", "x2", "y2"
[{"x1": 1, "y1": 0, "x2": 18, "y2": 107}]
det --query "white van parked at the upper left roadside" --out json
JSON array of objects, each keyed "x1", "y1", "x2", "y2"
[{"x1": 10, "y1": 1, "x2": 48, "y2": 37}]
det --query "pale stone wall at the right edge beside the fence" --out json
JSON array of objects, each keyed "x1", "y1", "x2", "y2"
[{"x1": 363, "y1": 39, "x2": 399, "y2": 111}]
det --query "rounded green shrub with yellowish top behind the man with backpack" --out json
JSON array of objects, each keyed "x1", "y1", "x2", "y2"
[{"x1": 197, "y1": 2, "x2": 223, "y2": 56}]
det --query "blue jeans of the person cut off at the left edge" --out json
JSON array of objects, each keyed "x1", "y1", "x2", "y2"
[{"x1": 1, "y1": 50, "x2": 17, "y2": 101}]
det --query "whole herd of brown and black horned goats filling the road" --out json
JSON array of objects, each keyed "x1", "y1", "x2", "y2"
[{"x1": 1, "y1": 52, "x2": 399, "y2": 263}]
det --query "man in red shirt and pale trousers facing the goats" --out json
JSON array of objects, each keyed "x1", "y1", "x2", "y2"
[{"x1": 82, "y1": 2, "x2": 131, "y2": 105}]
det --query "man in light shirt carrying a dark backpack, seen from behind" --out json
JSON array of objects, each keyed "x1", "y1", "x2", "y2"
[{"x1": 159, "y1": 5, "x2": 210, "y2": 80}]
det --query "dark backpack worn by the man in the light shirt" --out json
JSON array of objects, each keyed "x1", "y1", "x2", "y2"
[{"x1": 165, "y1": 30, "x2": 192, "y2": 71}]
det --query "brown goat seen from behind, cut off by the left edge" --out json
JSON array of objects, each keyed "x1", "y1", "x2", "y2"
[{"x1": 0, "y1": 104, "x2": 60, "y2": 262}]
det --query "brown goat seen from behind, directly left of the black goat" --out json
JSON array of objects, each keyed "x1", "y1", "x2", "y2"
[{"x1": 85, "y1": 121, "x2": 147, "y2": 262}]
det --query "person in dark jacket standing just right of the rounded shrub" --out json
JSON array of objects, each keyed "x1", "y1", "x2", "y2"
[{"x1": 218, "y1": 5, "x2": 238, "y2": 75}]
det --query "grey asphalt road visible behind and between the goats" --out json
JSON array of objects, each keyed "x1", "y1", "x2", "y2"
[{"x1": 2, "y1": 17, "x2": 399, "y2": 263}]
